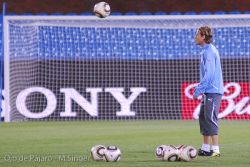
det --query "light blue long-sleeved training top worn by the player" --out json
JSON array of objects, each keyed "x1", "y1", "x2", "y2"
[{"x1": 194, "y1": 44, "x2": 224, "y2": 97}]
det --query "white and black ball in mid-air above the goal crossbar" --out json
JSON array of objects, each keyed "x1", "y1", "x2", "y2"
[{"x1": 93, "y1": 2, "x2": 111, "y2": 18}]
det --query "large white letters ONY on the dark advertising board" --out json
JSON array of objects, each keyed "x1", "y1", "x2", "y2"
[{"x1": 16, "y1": 87, "x2": 147, "y2": 119}]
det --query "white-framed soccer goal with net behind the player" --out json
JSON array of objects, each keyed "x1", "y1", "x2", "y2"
[{"x1": 4, "y1": 15, "x2": 250, "y2": 121}]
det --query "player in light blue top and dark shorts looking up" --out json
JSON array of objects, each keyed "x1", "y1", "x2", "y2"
[{"x1": 193, "y1": 26, "x2": 224, "y2": 156}]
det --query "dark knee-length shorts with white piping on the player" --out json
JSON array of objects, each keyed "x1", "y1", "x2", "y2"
[{"x1": 199, "y1": 93, "x2": 222, "y2": 136}]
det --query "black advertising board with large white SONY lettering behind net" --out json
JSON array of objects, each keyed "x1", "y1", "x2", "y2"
[{"x1": 10, "y1": 59, "x2": 250, "y2": 120}]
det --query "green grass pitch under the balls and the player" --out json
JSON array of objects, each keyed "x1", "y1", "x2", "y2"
[{"x1": 0, "y1": 121, "x2": 250, "y2": 167}]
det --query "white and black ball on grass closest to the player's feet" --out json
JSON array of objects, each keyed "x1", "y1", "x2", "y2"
[{"x1": 179, "y1": 146, "x2": 197, "y2": 161}]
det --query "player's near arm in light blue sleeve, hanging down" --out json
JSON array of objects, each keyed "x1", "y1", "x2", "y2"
[{"x1": 194, "y1": 53, "x2": 215, "y2": 98}]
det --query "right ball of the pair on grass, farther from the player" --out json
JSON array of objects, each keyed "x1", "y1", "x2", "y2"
[{"x1": 104, "y1": 146, "x2": 121, "y2": 162}]
